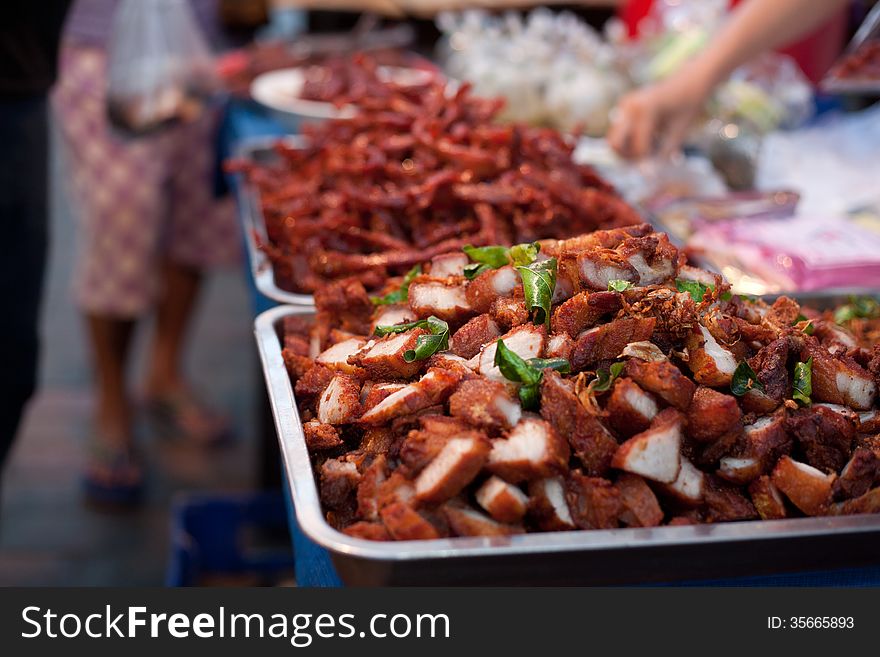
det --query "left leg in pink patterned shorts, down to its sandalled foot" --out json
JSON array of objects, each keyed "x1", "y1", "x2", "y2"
[{"x1": 55, "y1": 46, "x2": 168, "y2": 503}]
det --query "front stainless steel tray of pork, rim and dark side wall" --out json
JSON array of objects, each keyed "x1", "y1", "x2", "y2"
[{"x1": 255, "y1": 306, "x2": 880, "y2": 586}]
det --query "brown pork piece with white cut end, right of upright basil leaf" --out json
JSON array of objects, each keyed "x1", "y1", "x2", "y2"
[{"x1": 801, "y1": 337, "x2": 877, "y2": 411}]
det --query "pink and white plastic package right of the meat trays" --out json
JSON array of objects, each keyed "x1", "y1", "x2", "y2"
[{"x1": 688, "y1": 216, "x2": 880, "y2": 294}]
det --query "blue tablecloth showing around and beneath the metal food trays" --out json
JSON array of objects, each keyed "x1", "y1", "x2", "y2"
[{"x1": 220, "y1": 102, "x2": 880, "y2": 587}]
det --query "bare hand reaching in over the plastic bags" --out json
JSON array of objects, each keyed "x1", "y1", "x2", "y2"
[{"x1": 608, "y1": 69, "x2": 711, "y2": 159}]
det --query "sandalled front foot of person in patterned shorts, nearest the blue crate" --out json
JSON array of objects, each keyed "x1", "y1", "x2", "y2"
[{"x1": 83, "y1": 439, "x2": 144, "y2": 509}]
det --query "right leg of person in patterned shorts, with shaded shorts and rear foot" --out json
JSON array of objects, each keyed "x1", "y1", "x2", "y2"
[{"x1": 145, "y1": 116, "x2": 240, "y2": 443}]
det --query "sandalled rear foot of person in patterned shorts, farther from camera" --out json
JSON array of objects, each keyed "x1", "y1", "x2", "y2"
[{"x1": 144, "y1": 391, "x2": 232, "y2": 447}]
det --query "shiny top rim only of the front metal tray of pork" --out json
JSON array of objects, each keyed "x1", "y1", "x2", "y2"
[{"x1": 255, "y1": 306, "x2": 880, "y2": 562}]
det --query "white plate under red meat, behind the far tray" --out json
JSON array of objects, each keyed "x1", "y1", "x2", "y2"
[{"x1": 251, "y1": 66, "x2": 434, "y2": 120}]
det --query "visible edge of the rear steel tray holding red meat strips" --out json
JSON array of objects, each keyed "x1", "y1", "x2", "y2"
[{"x1": 234, "y1": 135, "x2": 314, "y2": 306}]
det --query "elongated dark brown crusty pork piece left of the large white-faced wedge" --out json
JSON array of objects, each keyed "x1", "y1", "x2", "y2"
[{"x1": 541, "y1": 370, "x2": 617, "y2": 476}]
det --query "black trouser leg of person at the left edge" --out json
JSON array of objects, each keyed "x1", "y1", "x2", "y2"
[{"x1": 0, "y1": 96, "x2": 49, "y2": 474}]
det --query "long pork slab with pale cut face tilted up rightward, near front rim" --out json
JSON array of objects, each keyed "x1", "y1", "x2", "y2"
[{"x1": 416, "y1": 431, "x2": 491, "y2": 504}]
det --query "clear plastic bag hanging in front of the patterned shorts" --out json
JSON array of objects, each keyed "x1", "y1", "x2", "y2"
[{"x1": 107, "y1": 0, "x2": 217, "y2": 135}]
